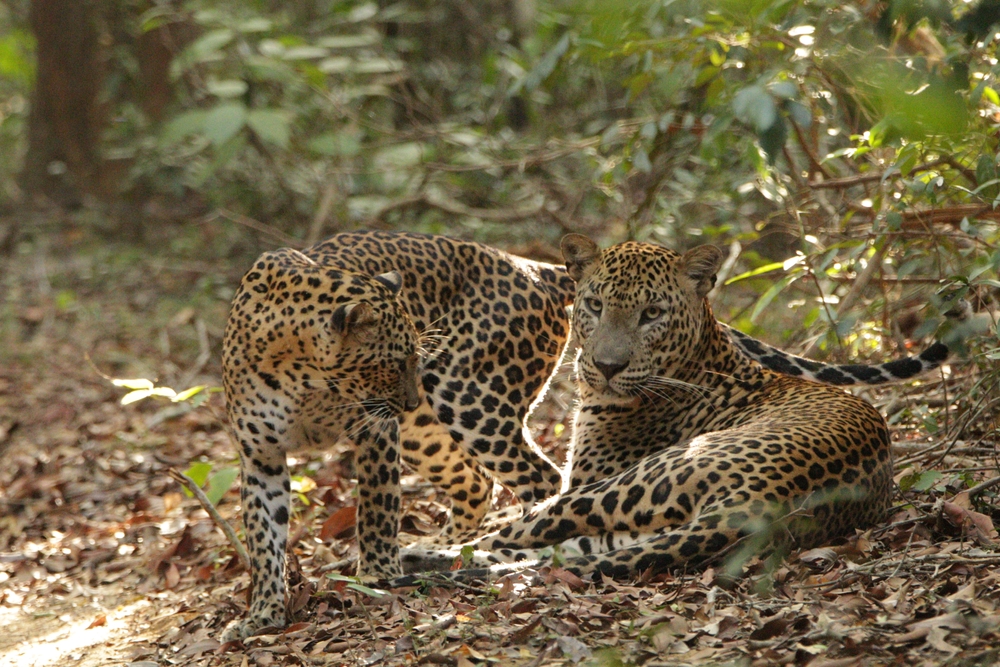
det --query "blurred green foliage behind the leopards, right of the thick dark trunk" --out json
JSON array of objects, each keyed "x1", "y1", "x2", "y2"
[{"x1": 11, "y1": 0, "x2": 1000, "y2": 400}]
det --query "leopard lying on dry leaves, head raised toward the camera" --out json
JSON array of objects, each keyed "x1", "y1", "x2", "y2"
[{"x1": 403, "y1": 235, "x2": 920, "y2": 577}]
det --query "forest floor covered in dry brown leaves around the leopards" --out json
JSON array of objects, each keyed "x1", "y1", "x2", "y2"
[{"x1": 0, "y1": 227, "x2": 1000, "y2": 667}]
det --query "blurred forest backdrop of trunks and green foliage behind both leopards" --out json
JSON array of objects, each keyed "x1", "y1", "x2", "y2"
[{"x1": 0, "y1": 0, "x2": 1000, "y2": 412}]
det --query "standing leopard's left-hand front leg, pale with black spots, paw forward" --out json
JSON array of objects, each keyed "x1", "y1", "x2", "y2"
[{"x1": 222, "y1": 440, "x2": 290, "y2": 641}]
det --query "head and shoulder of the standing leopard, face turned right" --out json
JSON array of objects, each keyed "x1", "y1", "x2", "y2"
[{"x1": 236, "y1": 250, "x2": 420, "y2": 416}]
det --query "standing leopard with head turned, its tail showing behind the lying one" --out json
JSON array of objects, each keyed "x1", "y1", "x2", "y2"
[{"x1": 223, "y1": 232, "x2": 946, "y2": 638}]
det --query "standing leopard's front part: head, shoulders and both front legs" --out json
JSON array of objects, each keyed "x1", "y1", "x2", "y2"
[{"x1": 222, "y1": 249, "x2": 420, "y2": 639}]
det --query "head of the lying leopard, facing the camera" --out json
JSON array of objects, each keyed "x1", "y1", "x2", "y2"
[{"x1": 562, "y1": 234, "x2": 722, "y2": 402}]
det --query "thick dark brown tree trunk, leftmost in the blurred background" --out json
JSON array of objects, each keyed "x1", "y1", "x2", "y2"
[{"x1": 21, "y1": 0, "x2": 107, "y2": 207}]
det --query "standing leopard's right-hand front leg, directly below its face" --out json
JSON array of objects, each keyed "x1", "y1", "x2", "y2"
[{"x1": 355, "y1": 419, "x2": 402, "y2": 580}]
